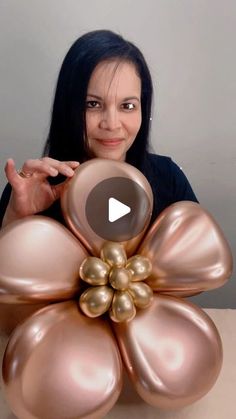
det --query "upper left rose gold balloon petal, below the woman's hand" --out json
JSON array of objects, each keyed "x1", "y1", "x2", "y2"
[{"x1": 0, "y1": 216, "x2": 88, "y2": 303}]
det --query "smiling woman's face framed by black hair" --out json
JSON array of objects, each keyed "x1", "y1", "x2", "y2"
[{"x1": 86, "y1": 61, "x2": 142, "y2": 161}]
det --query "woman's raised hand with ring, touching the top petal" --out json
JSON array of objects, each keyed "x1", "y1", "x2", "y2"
[{"x1": 3, "y1": 157, "x2": 79, "y2": 226}]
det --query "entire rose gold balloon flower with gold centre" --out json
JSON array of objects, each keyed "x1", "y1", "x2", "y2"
[{"x1": 0, "y1": 159, "x2": 232, "y2": 419}]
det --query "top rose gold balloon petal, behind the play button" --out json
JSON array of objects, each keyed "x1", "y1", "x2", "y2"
[{"x1": 61, "y1": 158, "x2": 153, "y2": 256}]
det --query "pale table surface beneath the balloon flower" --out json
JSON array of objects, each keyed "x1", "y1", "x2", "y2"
[{"x1": 0, "y1": 309, "x2": 236, "y2": 419}]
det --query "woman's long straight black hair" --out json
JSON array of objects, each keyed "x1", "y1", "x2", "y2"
[{"x1": 44, "y1": 30, "x2": 153, "y2": 171}]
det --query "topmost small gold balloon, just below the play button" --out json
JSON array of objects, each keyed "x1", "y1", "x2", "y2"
[{"x1": 101, "y1": 242, "x2": 127, "y2": 268}]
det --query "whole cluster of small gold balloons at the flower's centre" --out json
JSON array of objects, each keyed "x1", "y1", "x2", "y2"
[{"x1": 79, "y1": 242, "x2": 152, "y2": 322}]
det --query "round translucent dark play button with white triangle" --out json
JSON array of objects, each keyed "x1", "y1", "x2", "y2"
[{"x1": 85, "y1": 176, "x2": 150, "y2": 241}]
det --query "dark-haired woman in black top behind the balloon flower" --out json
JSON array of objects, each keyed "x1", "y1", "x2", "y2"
[{"x1": 0, "y1": 30, "x2": 197, "y2": 230}]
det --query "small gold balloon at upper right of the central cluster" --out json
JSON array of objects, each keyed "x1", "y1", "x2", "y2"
[{"x1": 125, "y1": 255, "x2": 152, "y2": 281}]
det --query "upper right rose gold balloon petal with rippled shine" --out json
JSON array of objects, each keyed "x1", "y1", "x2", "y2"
[{"x1": 138, "y1": 201, "x2": 232, "y2": 296}]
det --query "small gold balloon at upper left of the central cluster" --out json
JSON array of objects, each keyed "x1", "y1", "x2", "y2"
[{"x1": 79, "y1": 256, "x2": 110, "y2": 286}]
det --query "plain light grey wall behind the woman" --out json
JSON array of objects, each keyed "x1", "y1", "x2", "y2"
[{"x1": 0, "y1": 0, "x2": 236, "y2": 307}]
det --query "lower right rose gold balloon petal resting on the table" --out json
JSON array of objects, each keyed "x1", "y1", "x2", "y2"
[{"x1": 112, "y1": 296, "x2": 222, "y2": 409}]
